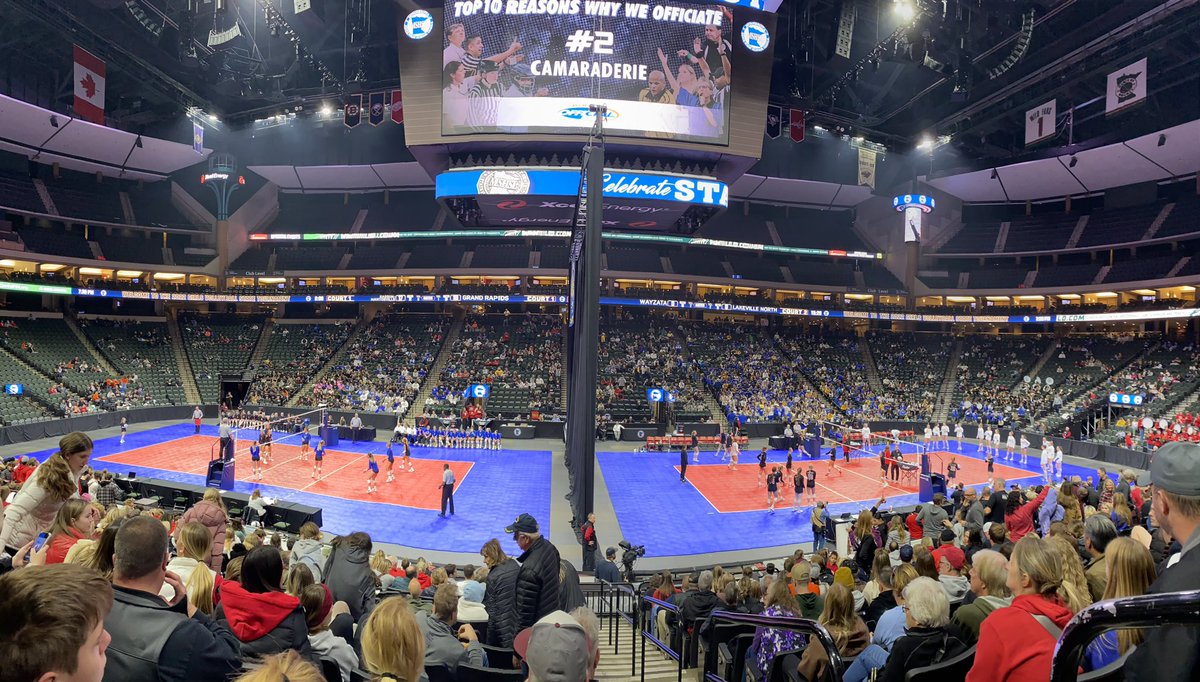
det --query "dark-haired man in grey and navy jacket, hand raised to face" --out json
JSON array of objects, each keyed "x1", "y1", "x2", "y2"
[{"x1": 104, "y1": 516, "x2": 241, "y2": 682}]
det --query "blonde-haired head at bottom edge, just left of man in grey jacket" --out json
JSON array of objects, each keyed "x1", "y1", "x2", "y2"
[{"x1": 362, "y1": 599, "x2": 425, "y2": 682}]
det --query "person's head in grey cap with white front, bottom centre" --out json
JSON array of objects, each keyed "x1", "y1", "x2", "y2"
[{"x1": 512, "y1": 610, "x2": 600, "y2": 682}]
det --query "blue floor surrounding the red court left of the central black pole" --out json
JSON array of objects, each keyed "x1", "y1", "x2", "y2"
[{"x1": 29, "y1": 423, "x2": 552, "y2": 554}]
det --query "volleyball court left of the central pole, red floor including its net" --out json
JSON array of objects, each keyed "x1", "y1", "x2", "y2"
[{"x1": 97, "y1": 409, "x2": 474, "y2": 510}]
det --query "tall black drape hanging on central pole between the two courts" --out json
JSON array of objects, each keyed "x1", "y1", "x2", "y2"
[{"x1": 566, "y1": 133, "x2": 604, "y2": 528}]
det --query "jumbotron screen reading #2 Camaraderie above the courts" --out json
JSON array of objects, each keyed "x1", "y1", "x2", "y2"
[{"x1": 401, "y1": 0, "x2": 774, "y2": 151}]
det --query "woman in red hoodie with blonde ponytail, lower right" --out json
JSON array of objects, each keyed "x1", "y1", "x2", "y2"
[{"x1": 967, "y1": 534, "x2": 1074, "y2": 682}]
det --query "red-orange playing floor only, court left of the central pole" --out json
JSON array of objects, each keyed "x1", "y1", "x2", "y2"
[{"x1": 92, "y1": 436, "x2": 474, "y2": 510}]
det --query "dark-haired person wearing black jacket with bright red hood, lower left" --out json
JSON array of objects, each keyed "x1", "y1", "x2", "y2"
[{"x1": 214, "y1": 545, "x2": 320, "y2": 664}]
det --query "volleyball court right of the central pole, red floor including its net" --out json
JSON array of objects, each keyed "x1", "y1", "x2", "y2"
[{"x1": 674, "y1": 423, "x2": 1030, "y2": 514}]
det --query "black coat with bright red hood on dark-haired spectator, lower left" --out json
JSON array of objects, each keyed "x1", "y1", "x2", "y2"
[{"x1": 212, "y1": 580, "x2": 319, "y2": 664}]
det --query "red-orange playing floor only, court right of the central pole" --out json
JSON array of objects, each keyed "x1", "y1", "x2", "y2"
[{"x1": 674, "y1": 451, "x2": 1031, "y2": 514}]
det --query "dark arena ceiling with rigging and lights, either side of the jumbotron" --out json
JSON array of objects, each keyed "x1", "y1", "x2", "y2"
[{"x1": 0, "y1": 0, "x2": 1200, "y2": 171}]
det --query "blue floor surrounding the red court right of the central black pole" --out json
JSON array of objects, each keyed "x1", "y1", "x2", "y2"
[{"x1": 596, "y1": 443, "x2": 1115, "y2": 557}]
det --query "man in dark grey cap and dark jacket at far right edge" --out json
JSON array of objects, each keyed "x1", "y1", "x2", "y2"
[{"x1": 1124, "y1": 442, "x2": 1200, "y2": 682}]
